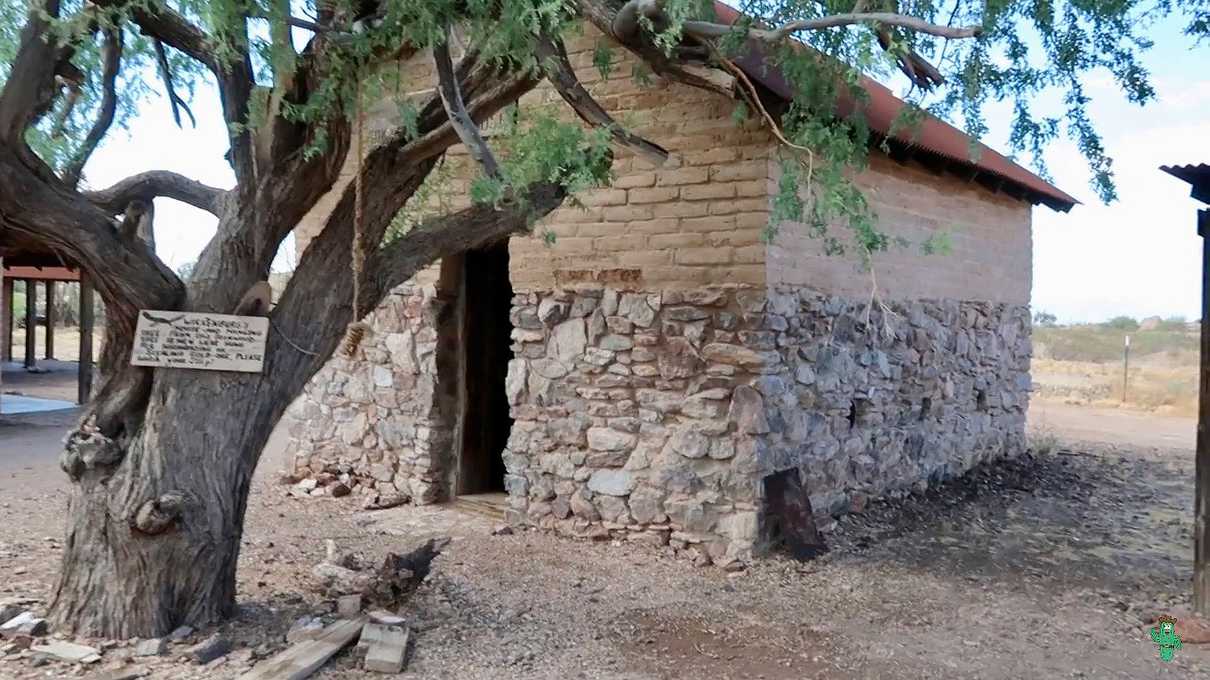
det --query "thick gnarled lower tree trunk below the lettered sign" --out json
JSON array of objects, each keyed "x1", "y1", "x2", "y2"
[{"x1": 52, "y1": 371, "x2": 274, "y2": 638}]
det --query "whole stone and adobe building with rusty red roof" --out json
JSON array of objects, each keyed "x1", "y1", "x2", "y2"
[{"x1": 290, "y1": 18, "x2": 1074, "y2": 561}]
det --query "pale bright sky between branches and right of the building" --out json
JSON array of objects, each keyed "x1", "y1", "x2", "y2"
[{"x1": 78, "y1": 12, "x2": 1210, "y2": 323}]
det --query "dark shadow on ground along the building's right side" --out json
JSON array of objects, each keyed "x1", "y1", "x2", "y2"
[{"x1": 831, "y1": 444, "x2": 1194, "y2": 609}]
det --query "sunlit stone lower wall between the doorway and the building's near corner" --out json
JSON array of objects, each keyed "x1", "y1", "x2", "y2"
[{"x1": 505, "y1": 287, "x2": 765, "y2": 561}]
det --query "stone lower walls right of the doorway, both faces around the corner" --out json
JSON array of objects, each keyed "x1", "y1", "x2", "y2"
[{"x1": 505, "y1": 288, "x2": 1030, "y2": 561}]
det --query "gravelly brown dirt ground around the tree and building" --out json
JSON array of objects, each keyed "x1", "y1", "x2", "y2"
[{"x1": 0, "y1": 394, "x2": 1210, "y2": 680}]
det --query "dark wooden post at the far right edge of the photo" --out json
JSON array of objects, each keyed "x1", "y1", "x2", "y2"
[{"x1": 1193, "y1": 211, "x2": 1210, "y2": 616}]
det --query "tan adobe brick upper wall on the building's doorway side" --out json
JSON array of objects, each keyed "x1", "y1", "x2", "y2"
[{"x1": 295, "y1": 28, "x2": 771, "y2": 292}]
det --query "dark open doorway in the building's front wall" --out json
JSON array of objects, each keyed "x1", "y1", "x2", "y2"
[{"x1": 456, "y1": 241, "x2": 513, "y2": 495}]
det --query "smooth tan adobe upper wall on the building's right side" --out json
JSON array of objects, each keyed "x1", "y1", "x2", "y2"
[{"x1": 768, "y1": 152, "x2": 1033, "y2": 305}]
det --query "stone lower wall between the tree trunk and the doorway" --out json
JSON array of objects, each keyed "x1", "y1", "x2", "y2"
[{"x1": 289, "y1": 275, "x2": 454, "y2": 503}]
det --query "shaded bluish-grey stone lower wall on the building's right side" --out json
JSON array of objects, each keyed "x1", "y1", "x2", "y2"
[{"x1": 749, "y1": 287, "x2": 1031, "y2": 513}]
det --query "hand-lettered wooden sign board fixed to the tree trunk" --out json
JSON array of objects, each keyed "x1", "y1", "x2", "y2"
[{"x1": 131, "y1": 310, "x2": 269, "y2": 373}]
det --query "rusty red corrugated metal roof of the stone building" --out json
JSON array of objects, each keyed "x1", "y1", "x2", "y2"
[{"x1": 714, "y1": 1, "x2": 1079, "y2": 212}]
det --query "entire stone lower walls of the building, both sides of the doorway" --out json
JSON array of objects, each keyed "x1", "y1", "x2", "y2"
[{"x1": 283, "y1": 275, "x2": 1031, "y2": 563}]
